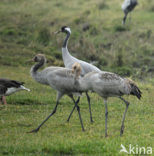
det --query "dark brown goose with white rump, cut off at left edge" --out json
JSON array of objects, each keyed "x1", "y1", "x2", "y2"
[{"x1": 0, "y1": 78, "x2": 30, "y2": 104}]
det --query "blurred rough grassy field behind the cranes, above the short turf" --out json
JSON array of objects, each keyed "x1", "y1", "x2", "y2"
[{"x1": 0, "y1": 0, "x2": 154, "y2": 78}]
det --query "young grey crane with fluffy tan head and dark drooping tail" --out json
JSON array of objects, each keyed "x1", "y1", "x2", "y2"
[{"x1": 73, "y1": 63, "x2": 141, "y2": 137}]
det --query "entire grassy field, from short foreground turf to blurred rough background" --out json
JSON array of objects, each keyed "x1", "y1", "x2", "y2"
[{"x1": 0, "y1": 0, "x2": 154, "y2": 156}]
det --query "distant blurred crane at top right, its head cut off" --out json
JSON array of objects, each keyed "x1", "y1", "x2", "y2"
[{"x1": 121, "y1": 0, "x2": 138, "y2": 24}]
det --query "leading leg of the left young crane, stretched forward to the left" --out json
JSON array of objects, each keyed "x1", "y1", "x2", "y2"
[{"x1": 28, "y1": 92, "x2": 64, "y2": 133}]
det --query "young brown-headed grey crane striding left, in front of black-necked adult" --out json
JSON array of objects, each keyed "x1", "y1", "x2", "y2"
[{"x1": 29, "y1": 54, "x2": 84, "y2": 133}]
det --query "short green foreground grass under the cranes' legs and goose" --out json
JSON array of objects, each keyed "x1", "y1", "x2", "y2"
[{"x1": 0, "y1": 66, "x2": 154, "y2": 156}]
